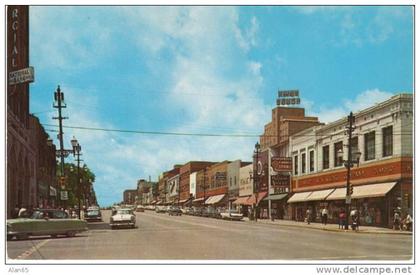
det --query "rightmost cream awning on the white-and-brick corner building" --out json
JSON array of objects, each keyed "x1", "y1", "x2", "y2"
[{"x1": 327, "y1": 182, "x2": 397, "y2": 200}]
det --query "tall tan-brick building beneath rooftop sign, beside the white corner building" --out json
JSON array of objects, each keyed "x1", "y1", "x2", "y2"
[{"x1": 254, "y1": 107, "x2": 320, "y2": 219}]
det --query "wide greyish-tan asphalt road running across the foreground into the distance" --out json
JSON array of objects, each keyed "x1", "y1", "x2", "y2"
[{"x1": 7, "y1": 211, "x2": 412, "y2": 261}]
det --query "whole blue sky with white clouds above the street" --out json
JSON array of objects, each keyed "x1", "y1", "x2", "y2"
[{"x1": 30, "y1": 6, "x2": 413, "y2": 205}]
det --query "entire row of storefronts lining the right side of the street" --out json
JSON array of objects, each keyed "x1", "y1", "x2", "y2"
[{"x1": 135, "y1": 94, "x2": 413, "y2": 227}]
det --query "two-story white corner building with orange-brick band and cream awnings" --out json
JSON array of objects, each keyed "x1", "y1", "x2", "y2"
[{"x1": 288, "y1": 94, "x2": 413, "y2": 226}]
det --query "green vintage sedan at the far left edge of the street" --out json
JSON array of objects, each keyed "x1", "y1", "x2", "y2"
[{"x1": 7, "y1": 209, "x2": 88, "y2": 240}]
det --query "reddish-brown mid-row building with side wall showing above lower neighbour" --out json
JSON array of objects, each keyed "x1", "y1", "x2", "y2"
[{"x1": 179, "y1": 161, "x2": 213, "y2": 204}]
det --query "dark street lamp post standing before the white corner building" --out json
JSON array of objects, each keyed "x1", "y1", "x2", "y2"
[{"x1": 337, "y1": 112, "x2": 361, "y2": 230}]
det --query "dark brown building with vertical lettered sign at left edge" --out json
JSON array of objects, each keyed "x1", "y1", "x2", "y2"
[{"x1": 6, "y1": 6, "x2": 38, "y2": 218}]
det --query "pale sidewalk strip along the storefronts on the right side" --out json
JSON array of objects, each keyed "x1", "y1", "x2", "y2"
[{"x1": 244, "y1": 218, "x2": 413, "y2": 235}]
